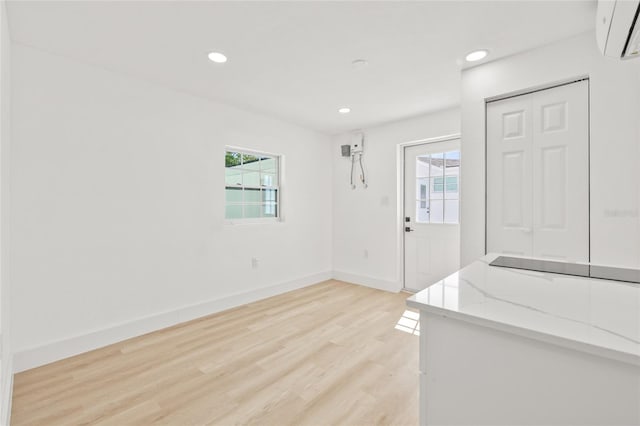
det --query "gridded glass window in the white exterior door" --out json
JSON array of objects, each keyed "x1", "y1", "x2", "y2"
[{"x1": 416, "y1": 151, "x2": 460, "y2": 223}]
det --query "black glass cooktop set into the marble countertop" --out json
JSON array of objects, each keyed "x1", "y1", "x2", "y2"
[{"x1": 489, "y1": 256, "x2": 640, "y2": 284}]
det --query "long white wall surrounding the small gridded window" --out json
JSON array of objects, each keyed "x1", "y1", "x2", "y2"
[{"x1": 10, "y1": 44, "x2": 332, "y2": 371}]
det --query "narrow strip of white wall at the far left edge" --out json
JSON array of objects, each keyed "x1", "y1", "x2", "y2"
[{"x1": 0, "y1": 1, "x2": 13, "y2": 425}]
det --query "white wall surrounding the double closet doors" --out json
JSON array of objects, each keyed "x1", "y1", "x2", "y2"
[{"x1": 461, "y1": 33, "x2": 640, "y2": 267}]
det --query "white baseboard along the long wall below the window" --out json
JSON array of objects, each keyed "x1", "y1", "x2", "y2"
[{"x1": 13, "y1": 271, "x2": 332, "y2": 373}]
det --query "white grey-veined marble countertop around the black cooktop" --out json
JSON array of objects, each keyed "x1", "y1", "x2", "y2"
[{"x1": 407, "y1": 254, "x2": 640, "y2": 366}]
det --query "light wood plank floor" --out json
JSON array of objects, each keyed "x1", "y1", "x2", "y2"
[{"x1": 12, "y1": 281, "x2": 418, "y2": 426}]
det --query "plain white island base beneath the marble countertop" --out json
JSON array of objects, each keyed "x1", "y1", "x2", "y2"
[{"x1": 420, "y1": 311, "x2": 640, "y2": 425}]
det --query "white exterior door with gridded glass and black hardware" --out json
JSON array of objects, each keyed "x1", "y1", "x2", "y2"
[{"x1": 403, "y1": 139, "x2": 460, "y2": 291}]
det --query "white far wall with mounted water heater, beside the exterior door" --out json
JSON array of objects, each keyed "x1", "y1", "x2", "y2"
[{"x1": 331, "y1": 109, "x2": 460, "y2": 291}]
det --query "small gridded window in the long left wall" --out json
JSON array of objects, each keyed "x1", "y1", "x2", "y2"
[{"x1": 224, "y1": 148, "x2": 280, "y2": 220}]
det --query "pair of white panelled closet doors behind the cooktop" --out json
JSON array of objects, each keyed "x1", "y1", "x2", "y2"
[{"x1": 487, "y1": 81, "x2": 589, "y2": 262}]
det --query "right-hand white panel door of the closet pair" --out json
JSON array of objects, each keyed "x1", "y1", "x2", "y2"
[{"x1": 532, "y1": 81, "x2": 589, "y2": 262}]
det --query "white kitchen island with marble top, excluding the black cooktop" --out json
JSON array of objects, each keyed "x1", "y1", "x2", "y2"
[{"x1": 407, "y1": 254, "x2": 640, "y2": 425}]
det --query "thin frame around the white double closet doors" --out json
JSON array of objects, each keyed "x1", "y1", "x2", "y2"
[{"x1": 484, "y1": 75, "x2": 591, "y2": 262}]
